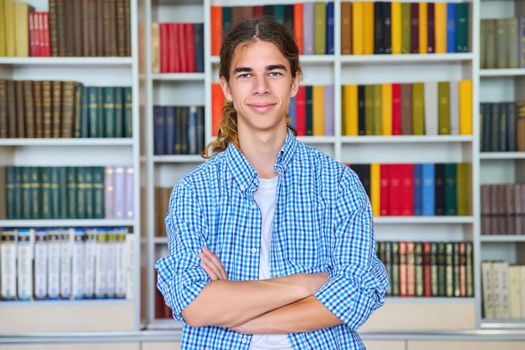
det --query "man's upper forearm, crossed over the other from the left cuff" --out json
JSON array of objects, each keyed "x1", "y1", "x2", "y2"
[{"x1": 182, "y1": 275, "x2": 313, "y2": 327}]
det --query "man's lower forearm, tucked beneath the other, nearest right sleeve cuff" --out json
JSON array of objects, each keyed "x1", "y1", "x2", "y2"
[{"x1": 233, "y1": 296, "x2": 342, "y2": 334}]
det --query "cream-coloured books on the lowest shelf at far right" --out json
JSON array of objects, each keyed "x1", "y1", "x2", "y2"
[{"x1": 481, "y1": 261, "x2": 525, "y2": 320}]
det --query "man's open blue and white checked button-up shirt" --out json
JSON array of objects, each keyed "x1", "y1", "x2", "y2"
[{"x1": 155, "y1": 130, "x2": 388, "y2": 350}]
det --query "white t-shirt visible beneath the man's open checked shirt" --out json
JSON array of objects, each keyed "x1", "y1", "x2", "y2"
[{"x1": 250, "y1": 177, "x2": 292, "y2": 350}]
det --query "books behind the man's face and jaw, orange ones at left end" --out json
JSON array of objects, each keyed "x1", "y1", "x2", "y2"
[{"x1": 212, "y1": 84, "x2": 334, "y2": 136}]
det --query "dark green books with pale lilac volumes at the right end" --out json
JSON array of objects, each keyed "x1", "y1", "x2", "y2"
[{"x1": 2, "y1": 166, "x2": 134, "y2": 219}]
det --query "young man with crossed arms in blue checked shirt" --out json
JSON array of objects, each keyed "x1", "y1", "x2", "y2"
[{"x1": 156, "y1": 19, "x2": 388, "y2": 349}]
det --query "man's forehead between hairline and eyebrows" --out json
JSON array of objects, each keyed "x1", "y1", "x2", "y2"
[{"x1": 231, "y1": 40, "x2": 290, "y2": 70}]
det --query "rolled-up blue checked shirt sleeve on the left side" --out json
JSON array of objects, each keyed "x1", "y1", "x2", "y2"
[{"x1": 155, "y1": 182, "x2": 211, "y2": 322}]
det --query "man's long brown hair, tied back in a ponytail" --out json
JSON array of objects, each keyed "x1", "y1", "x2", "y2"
[{"x1": 201, "y1": 17, "x2": 301, "y2": 159}]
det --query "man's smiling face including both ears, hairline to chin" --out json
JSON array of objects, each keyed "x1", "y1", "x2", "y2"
[{"x1": 221, "y1": 40, "x2": 300, "y2": 138}]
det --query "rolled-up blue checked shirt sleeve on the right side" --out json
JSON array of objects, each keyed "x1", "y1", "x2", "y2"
[{"x1": 315, "y1": 168, "x2": 388, "y2": 330}]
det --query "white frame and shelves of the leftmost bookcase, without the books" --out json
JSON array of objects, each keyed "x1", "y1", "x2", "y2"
[{"x1": 0, "y1": 0, "x2": 141, "y2": 335}]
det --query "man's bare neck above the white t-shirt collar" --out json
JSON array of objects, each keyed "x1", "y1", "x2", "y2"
[{"x1": 238, "y1": 125, "x2": 288, "y2": 179}]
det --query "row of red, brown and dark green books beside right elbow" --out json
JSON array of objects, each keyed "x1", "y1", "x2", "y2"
[{"x1": 376, "y1": 242, "x2": 474, "y2": 297}]
